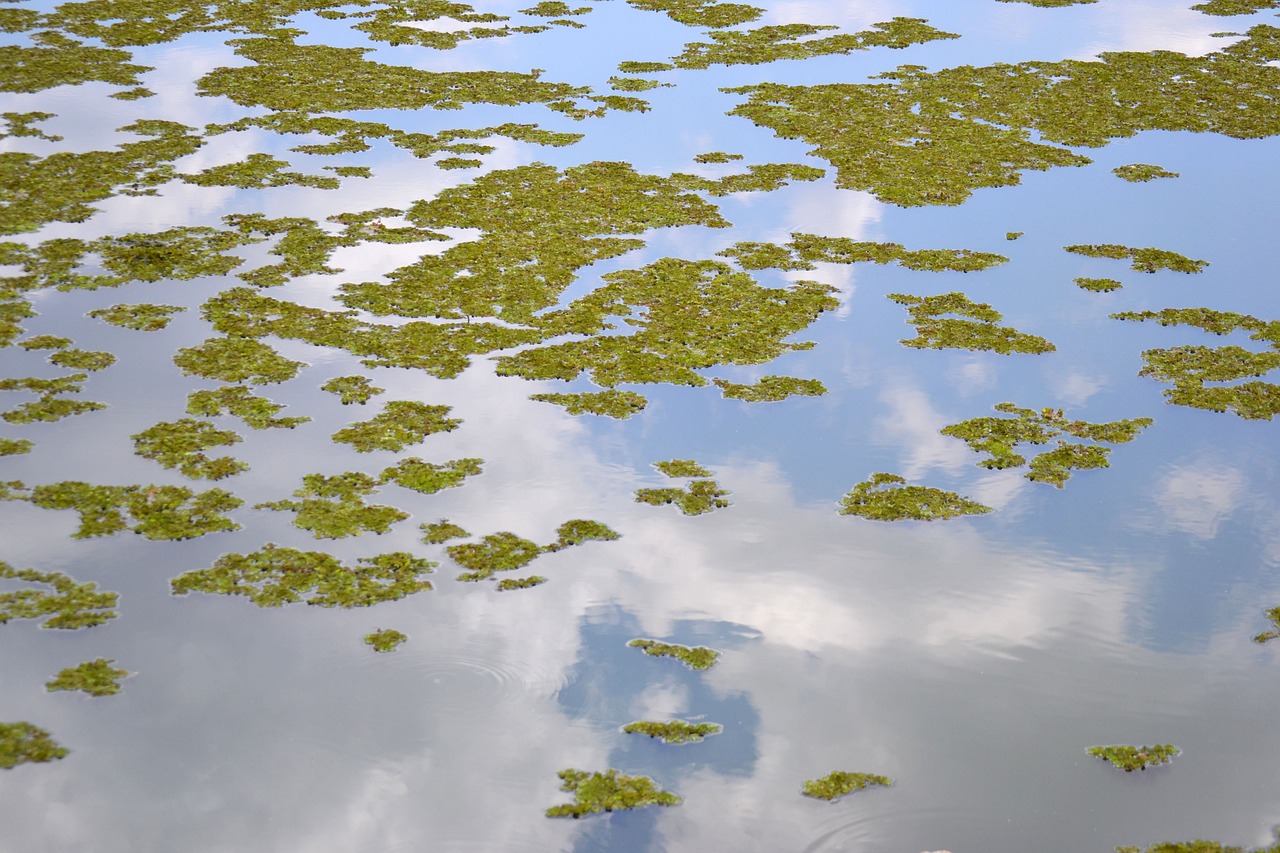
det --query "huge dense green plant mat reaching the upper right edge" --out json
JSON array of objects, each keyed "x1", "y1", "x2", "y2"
[{"x1": 726, "y1": 24, "x2": 1280, "y2": 206}]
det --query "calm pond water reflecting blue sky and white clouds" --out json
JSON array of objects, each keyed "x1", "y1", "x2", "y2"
[{"x1": 0, "y1": 0, "x2": 1280, "y2": 853}]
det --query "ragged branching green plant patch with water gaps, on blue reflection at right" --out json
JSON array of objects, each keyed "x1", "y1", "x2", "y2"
[{"x1": 941, "y1": 402, "x2": 1155, "y2": 488}]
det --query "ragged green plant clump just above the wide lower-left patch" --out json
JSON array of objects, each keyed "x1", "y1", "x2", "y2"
[{"x1": 253, "y1": 471, "x2": 408, "y2": 539}]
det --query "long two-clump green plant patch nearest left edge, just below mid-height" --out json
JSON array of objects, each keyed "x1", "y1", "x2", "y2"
[{"x1": 14, "y1": 480, "x2": 244, "y2": 539}]
